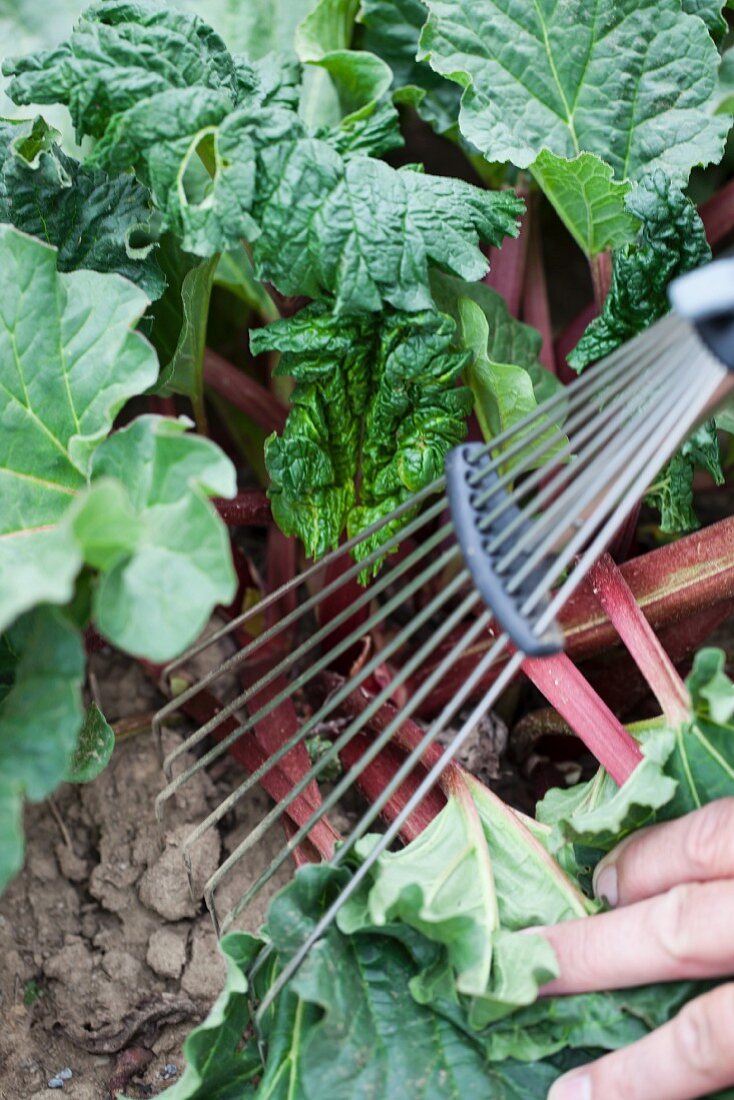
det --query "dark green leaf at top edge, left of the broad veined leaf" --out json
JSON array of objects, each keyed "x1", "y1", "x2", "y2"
[{"x1": 359, "y1": 0, "x2": 461, "y2": 133}]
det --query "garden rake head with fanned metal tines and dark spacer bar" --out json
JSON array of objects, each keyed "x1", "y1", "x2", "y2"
[{"x1": 155, "y1": 260, "x2": 734, "y2": 1018}]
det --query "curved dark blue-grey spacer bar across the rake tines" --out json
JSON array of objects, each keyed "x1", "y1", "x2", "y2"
[{"x1": 446, "y1": 443, "x2": 563, "y2": 657}]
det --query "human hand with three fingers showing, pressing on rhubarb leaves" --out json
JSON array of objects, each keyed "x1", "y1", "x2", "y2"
[{"x1": 533, "y1": 799, "x2": 734, "y2": 1100}]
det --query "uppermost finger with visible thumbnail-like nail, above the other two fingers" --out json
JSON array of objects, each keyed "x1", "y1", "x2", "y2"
[{"x1": 594, "y1": 798, "x2": 734, "y2": 905}]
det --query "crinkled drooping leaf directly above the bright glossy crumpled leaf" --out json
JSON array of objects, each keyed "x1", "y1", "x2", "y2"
[{"x1": 255, "y1": 147, "x2": 522, "y2": 314}]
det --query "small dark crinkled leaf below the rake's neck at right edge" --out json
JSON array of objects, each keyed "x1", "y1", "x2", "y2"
[{"x1": 645, "y1": 420, "x2": 724, "y2": 535}]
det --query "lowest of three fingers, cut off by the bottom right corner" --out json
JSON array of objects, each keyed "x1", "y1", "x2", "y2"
[{"x1": 548, "y1": 983, "x2": 734, "y2": 1100}]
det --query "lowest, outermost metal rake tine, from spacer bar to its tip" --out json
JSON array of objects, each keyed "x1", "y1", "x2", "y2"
[{"x1": 250, "y1": 635, "x2": 524, "y2": 1026}]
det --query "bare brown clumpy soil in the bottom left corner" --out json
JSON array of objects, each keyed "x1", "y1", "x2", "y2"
[{"x1": 0, "y1": 653, "x2": 292, "y2": 1100}]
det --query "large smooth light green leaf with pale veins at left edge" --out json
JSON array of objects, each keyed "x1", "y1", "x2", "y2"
[{"x1": 0, "y1": 226, "x2": 157, "y2": 626}]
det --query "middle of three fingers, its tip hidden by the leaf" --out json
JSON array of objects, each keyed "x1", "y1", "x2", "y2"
[{"x1": 533, "y1": 881, "x2": 734, "y2": 994}]
